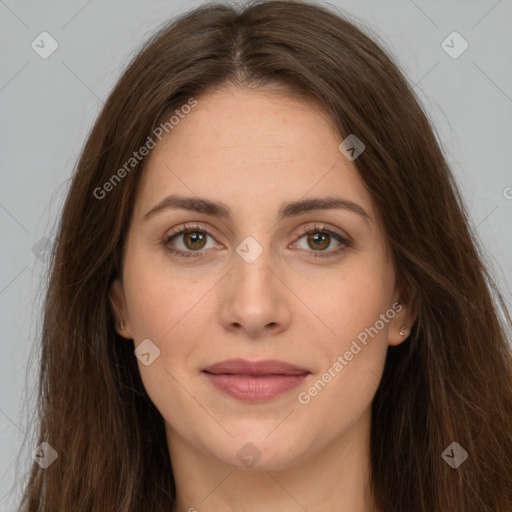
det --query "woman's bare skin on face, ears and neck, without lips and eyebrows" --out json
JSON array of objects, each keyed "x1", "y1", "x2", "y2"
[{"x1": 110, "y1": 87, "x2": 415, "y2": 512}]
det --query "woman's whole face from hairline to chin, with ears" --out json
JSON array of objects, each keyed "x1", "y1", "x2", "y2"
[{"x1": 111, "y1": 85, "x2": 412, "y2": 469}]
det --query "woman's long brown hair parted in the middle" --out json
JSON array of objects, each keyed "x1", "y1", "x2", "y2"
[{"x1": 16, "y1": 1, "x2": 512, "y2": 512}]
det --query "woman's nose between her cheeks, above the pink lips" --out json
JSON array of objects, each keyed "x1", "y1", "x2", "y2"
[{"x1": 219, "y1": 245, "x2": 293, "y2": 339}]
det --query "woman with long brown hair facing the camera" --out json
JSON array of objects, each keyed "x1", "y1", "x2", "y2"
[{"x1": 16, "y1": 1, "x2": 512, "y2": 512}]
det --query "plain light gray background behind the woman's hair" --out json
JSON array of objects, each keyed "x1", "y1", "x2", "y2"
[{"x1": 0, "y1": 0, "x2": 512, "y2": 511}]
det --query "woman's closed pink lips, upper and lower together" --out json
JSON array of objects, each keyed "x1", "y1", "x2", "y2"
[{"x1": 203, "y1": 359, "x2": 310, "y2": 402}]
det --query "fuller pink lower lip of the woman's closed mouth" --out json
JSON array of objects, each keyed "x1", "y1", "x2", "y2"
[{"x1": 204, "y1": 372, "x2": 308, "y2": 402}]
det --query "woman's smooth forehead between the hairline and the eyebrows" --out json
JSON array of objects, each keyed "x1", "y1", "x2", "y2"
[{"x1": 132, "y1": 88, "x2": 372, "y2": 222}]
